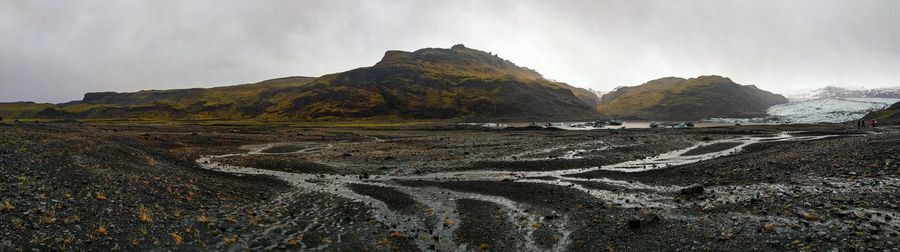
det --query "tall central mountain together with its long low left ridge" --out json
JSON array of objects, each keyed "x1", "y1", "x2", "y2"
[{"x1": 21, "y1": 45, "x2": 598, "y2": 121}]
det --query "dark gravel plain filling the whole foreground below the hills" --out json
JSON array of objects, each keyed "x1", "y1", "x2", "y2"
[{"x1": 0, "y1": 124, "x2": 900, "y2": 251}]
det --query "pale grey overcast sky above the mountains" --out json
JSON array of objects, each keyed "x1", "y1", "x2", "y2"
[{"x1": 0, "y1": 0, "x2": 900, "y2": 102}]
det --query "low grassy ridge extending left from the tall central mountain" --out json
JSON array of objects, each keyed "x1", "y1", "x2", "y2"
[{"x1": 29, "y1": 76, "x2": 315, "y2": 120}]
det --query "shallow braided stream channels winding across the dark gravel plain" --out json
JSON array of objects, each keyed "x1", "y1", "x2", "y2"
[{"x1": 196, "y1": 132, "x2": 852, "y2": 250}]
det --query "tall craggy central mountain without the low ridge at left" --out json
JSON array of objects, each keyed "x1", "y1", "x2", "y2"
[{"x1": 270, "y1": 45, "x2": 596, "y2": 119}]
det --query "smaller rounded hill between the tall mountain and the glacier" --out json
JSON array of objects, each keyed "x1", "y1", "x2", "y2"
[{"x1": 598, "y1": 76, "x2": 787, "y2": 120}]
